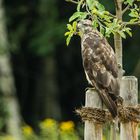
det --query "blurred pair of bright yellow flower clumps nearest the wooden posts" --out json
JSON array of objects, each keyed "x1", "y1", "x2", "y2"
[{"x1": 40, "y1": 119, "x2": 80, "y2": 140}]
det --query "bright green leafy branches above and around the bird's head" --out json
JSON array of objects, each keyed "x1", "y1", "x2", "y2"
[{"x1": 65, "y1": 0, "x2": 140, "y2": 45}]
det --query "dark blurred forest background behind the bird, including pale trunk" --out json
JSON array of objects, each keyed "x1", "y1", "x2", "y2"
[{"x1": 0, "y1": 0, "x2": 140, "y2": 139}]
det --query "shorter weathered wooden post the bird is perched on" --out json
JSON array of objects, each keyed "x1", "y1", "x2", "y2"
[{"x1": 84, "y1": 89, "x2": 102, "y2": 140}]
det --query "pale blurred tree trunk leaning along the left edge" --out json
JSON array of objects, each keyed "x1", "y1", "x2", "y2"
[{"x1": 0, "y1": 0, "x2": 21, "y2": 140}]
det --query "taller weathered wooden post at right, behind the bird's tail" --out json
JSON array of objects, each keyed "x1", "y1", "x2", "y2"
[{"x1": 120, "y1": 76, "x2": 138, "y2": 140}]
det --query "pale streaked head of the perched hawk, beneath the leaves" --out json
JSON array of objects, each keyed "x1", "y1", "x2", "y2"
[{"x1": 77, "y1": 19, "x2": 93, "y2": 34}]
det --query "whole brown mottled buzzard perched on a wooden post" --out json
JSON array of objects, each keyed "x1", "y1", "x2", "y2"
[{"x1": 77, "y1": 20, "x2": 120, "y2": 118}]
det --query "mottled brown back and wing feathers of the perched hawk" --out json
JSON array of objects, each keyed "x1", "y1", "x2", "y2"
[{"x1": 81, "y1": 32, "x2": 118, "y2": 92}]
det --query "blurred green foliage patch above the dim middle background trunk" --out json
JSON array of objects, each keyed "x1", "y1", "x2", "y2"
[{"x1": 29, "y1": 0, "x2": 64, "y2": 56}]
